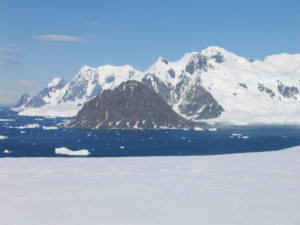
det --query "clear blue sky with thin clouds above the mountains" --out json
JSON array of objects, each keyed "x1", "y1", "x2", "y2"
[{"x1": 0, "y1": 0, "x2": 300, "y2": 105}]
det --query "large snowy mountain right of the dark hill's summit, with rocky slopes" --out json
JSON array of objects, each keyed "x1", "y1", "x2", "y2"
[{"x1": 139, "y1": 47, "x2": 300, "y2": 123}]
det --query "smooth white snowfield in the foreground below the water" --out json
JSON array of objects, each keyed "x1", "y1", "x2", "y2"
[{"x1": 0, "y1": 147, "x2": 300, "y2": 225}]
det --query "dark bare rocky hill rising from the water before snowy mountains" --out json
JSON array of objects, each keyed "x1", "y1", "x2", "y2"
[{"x1": 67, "y1": 80, "x2": 194, "y2": 129}]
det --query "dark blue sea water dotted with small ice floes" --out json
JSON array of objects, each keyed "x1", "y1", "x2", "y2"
[{"x1": 0, "y1": 109, "x2": 300, "y2": 157}]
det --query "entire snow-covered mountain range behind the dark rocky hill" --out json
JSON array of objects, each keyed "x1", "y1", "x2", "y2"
[{"x1": 15, "y1": 47, "x2": 300, "y2": 123}]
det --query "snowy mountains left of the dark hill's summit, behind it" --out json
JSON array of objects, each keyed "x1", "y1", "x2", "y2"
[{"x1": 16, "y1": 65, "x2": 140, "y2": 117}]
